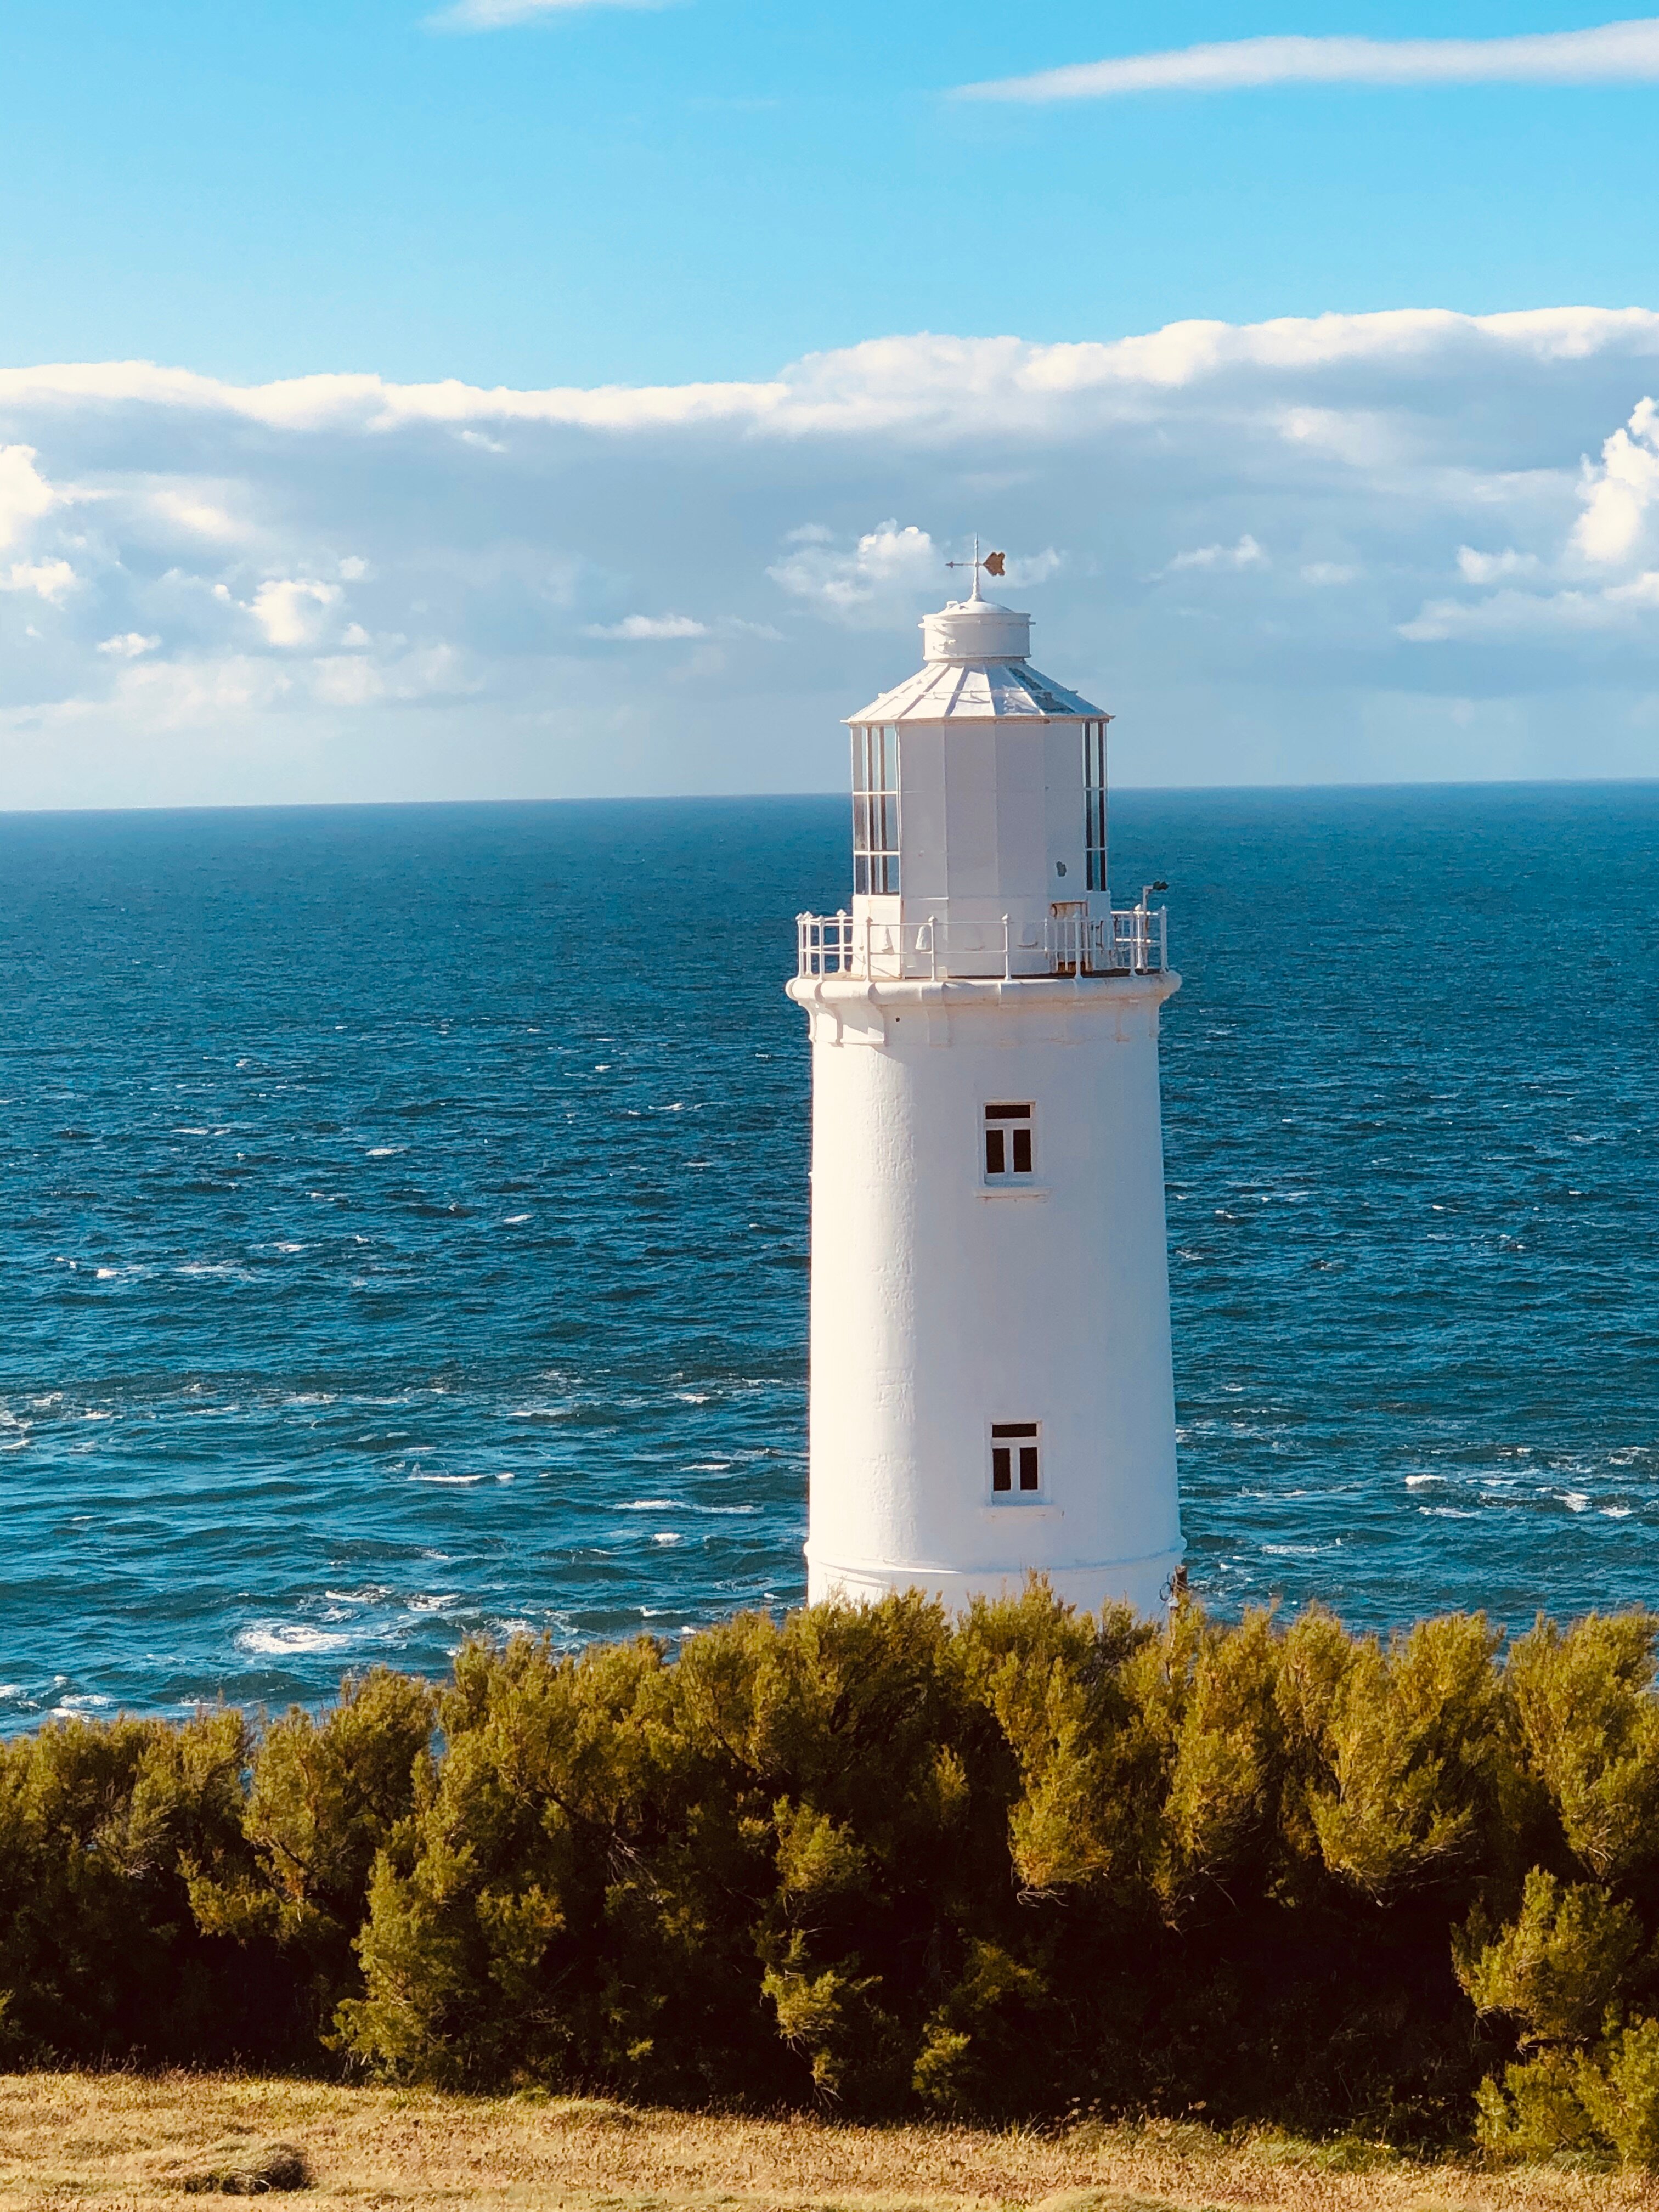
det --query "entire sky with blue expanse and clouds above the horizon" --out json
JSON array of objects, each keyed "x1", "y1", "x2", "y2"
[{"x1": 0, "y1": 0, "x2": 1659, "y2": 808}]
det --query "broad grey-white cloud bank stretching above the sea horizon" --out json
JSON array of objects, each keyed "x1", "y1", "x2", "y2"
[{"x1": 0, "y1": 307, "x2": 1659, "y2": 805}]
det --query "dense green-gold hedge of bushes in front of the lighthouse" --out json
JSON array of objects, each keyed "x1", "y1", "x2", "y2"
[{"x1": 0, "y1": 1584, "x2": 1659, "y2": 2165}]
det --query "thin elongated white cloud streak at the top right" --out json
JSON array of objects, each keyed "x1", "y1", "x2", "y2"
[{"x1": 960, "y1": 15, "x2": 1659, "y2": 101}]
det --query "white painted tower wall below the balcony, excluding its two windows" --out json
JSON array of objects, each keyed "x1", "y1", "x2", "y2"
[{"x1": 789, "y1": 975, "x2": 1181, "y2": 1612}]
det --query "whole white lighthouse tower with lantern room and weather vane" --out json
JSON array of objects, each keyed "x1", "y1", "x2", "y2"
[{"x1": 787, "y1": 546, "x2": 1183, "y2": 1615}]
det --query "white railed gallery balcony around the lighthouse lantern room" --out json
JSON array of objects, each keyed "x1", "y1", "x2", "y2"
[{"x1": 797, "y1": 907, "x2": 1168, "y2": 982}]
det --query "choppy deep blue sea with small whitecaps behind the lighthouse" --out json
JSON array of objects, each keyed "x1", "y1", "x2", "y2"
[{"x1": 0, "y1": 785, "x2": 1659, "y2": 1728}]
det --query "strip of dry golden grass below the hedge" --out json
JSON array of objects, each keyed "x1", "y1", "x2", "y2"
[{"x1": 0, "y1": 2073, "x2": 1659, "y2": 2212}]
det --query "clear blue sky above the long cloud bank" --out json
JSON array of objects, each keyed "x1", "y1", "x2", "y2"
[{"x1": 0, "y1": 0, "x2": 1659, "y2": 385}]
